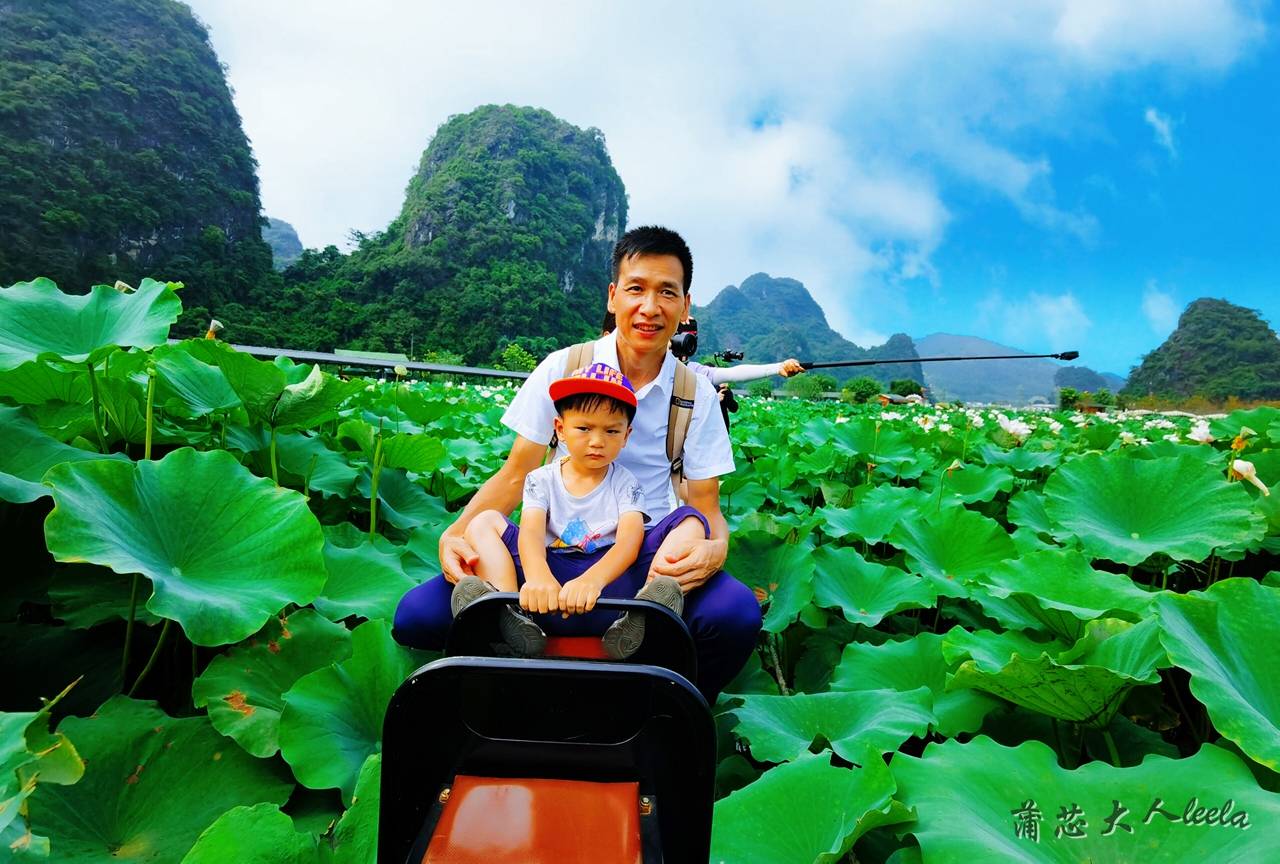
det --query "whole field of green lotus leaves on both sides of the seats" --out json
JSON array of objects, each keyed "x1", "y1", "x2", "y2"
[{"x1": 0, "y1": 280, "x2": 1280, "y2": 864}]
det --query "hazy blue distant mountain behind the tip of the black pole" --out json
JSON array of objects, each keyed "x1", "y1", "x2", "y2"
[{"x1": 915, "y1": 333, "x2": 1125, "y2": 404}]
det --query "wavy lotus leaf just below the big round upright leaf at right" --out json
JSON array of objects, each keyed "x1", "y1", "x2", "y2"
[{"x1": 970, "y1": 549, "x2": 1155, "y2": 641}]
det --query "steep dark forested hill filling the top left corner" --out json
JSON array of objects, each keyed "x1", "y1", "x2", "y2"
[{"x1": 0, "y1": 0, "x2": 271, "y2": 307}]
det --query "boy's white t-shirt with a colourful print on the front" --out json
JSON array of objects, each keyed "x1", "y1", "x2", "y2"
[{"x1": 524, "y1": 460, "x2": 644, "y2": 552}]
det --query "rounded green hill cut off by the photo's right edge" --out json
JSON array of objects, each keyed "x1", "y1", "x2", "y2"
[{"x1": 1124, "y1": 297, "x2": 1280, "y2": 399}]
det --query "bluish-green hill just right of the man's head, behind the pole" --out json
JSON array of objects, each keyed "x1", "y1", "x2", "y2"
[{"x1": 694, "y1": 273, "x2": 924, "y2": 383}]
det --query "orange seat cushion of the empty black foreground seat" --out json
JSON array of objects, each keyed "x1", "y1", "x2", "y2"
[{"x1": 422, "y1": 776, "x2": 641, "y2": 864}]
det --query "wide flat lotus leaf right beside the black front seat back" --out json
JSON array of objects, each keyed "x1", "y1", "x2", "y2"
[{"x1": 733, "y1": 687, "x2": 936, "y2": 763}]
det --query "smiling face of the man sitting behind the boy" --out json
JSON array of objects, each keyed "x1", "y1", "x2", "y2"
[{"x1": 609, "y1": 255, "x2": 689, "y2": 353}]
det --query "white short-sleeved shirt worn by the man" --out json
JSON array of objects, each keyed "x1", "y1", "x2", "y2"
[{"x1": 502, "y1": 333, "x2": 733, "y2": 521}]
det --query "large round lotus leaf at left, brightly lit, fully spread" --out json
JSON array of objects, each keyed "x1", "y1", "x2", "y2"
[{"x1": 45, "y1": 448, "x2": 325, "y2": 645}]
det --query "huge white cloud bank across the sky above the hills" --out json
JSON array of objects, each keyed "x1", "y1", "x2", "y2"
[{"x1": 191, "y1": 0, "x2": 1261, "y2": 340}]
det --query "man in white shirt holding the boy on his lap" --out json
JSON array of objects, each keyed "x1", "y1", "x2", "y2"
[{"x1": 394, "y1": 227, "x2": 760, "y2": 704}]
